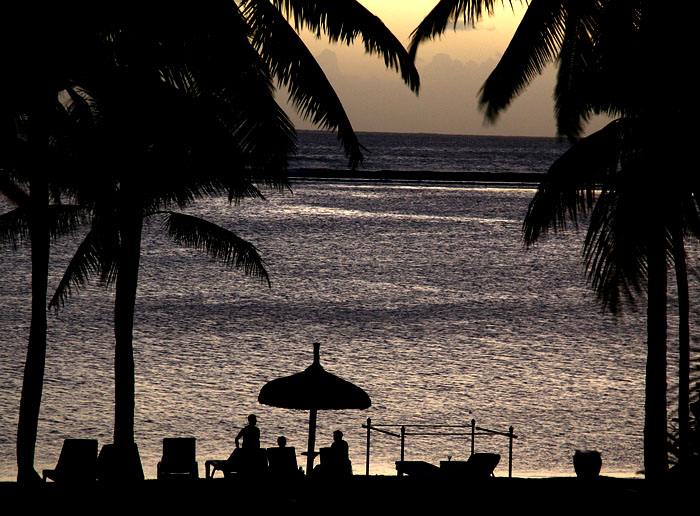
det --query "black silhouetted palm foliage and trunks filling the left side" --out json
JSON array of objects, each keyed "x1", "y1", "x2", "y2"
[{"x1": 0, "y1": 0, "x2": 418, "y2": 480}]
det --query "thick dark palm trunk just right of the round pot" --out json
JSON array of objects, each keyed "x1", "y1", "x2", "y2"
[{"x1": 644, "y1": 223, "x2": 668, "y2": 481}]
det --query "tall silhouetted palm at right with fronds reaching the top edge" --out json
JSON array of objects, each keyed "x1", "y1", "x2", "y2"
[{"x1": 409, "y1": 0, "x2": 697, "y2": 477}]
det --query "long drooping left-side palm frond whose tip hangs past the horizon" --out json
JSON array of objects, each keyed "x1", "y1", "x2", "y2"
[{"x1": 243, "y1": 0, "x2": 362, "y2": 169}]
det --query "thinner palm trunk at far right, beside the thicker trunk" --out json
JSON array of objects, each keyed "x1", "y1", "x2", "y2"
[{"x1": 673, "y1": 227, "x2": 690, "y2": 468}]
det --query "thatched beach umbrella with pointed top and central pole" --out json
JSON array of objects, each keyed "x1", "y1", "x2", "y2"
[{"x1": 258, "y1": 343, "x2": 372, "y2": 475}]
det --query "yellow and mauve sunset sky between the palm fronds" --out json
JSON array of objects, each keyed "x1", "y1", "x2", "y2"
[{"x1": 282, "y1": 0, "x2": 600, "y2": 136}]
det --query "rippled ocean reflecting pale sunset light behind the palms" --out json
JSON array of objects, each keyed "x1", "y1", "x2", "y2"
[{"x1": 0, "y1": 132, "x2": 698, "y2": 480}]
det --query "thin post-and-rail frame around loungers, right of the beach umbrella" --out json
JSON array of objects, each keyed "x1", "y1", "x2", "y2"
[{"x1": 362, "y1": 418, "x2": 518, "y2": 478}]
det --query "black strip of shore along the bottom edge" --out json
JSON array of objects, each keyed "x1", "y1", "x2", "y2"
[{"x1": 0, "y1": 475, "x2": 696, "y2": 515}]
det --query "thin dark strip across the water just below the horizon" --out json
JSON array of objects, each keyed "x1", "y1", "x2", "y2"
[{"x1": 288, "y1": 168, "x2": 545, "y2": 185}]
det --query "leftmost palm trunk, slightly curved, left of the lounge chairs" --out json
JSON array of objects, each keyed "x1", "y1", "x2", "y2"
[{"x1": 17, "y1": 172, "x2": 50, "y2": 483}]
